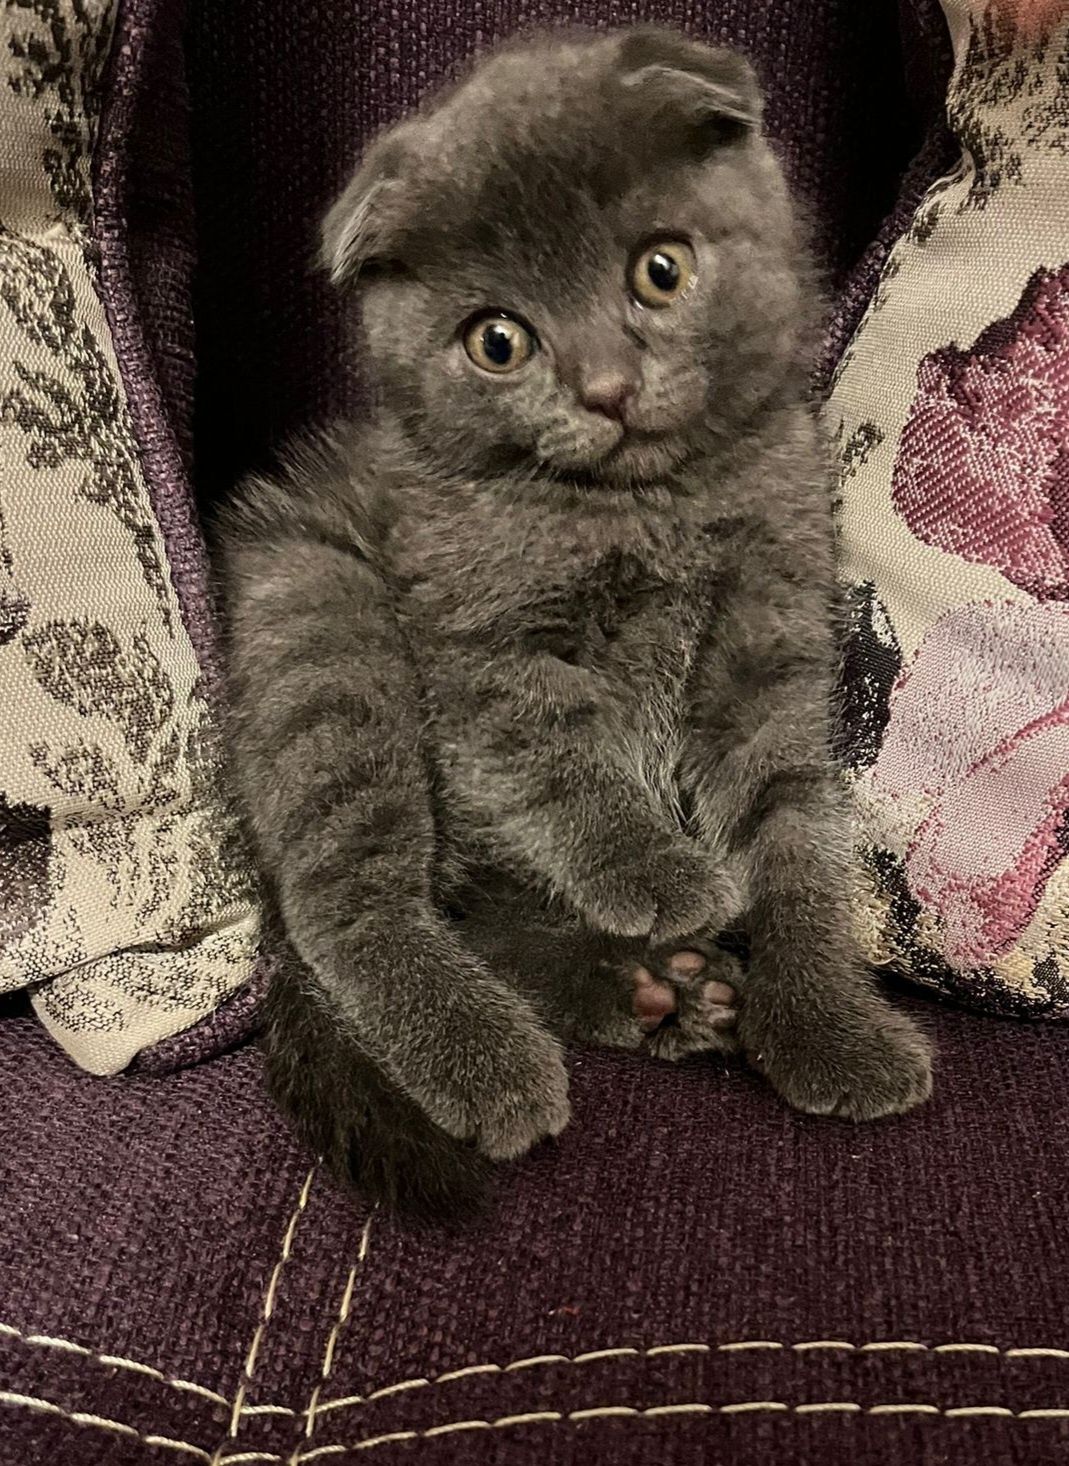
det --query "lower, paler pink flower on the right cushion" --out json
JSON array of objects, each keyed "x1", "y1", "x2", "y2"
[{"x1": 871, "y1": 601, "x2": 1069, "y2": 966}]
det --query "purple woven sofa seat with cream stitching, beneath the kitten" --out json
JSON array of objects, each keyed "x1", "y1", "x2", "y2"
[{"x1": 0, "y1": 1010, "x2": 1069, "y2": 1466}]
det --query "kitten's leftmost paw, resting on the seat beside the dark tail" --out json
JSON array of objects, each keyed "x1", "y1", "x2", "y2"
[{"x1": 415, "y1": 1019, "x2": 570, "y2": 1161}]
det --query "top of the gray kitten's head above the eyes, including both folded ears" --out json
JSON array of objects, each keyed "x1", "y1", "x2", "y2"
[{"x1": 323, "y1": 28, "x2": 779, "y2": 296}]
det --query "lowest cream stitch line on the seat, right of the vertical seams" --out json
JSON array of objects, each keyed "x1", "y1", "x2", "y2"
[{"x1": 280, "y1": 1400, "x2": 1069, "y2": 1466}]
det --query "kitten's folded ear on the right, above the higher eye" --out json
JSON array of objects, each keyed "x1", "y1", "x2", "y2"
[{"x1": 619, "y1": 31, "x2": 763, "y2": 147}]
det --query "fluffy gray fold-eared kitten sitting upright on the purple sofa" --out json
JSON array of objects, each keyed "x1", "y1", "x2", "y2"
[{"x1": 224, "y1": 29, "x2": 931, "y2": 1211}]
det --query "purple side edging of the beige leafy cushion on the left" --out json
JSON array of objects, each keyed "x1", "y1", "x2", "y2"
[{"x1": 80, "y1": 0, "x2": 264, "y2": 1073}]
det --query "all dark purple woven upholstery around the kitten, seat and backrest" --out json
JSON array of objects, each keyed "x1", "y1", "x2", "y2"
[{"x1": 10, "y1": 0, "x2": 1069, "y2": 1466}]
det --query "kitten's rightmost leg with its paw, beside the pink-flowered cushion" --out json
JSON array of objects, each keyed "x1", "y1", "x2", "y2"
[{"x1": 683, "y1": 526, "x2": 931, "y2": 1120}]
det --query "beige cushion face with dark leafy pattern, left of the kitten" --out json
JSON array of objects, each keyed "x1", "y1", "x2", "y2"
[{"x1": 0, "y1": 0, "x2": 258, "y2": 1073}]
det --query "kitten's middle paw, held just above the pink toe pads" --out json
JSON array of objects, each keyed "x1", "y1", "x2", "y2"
[{"x1": 573, "y1": 837, "x2": 738, "y2": 941}]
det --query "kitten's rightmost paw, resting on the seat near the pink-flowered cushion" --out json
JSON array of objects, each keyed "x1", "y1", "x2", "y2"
[{"x1": 742, "y1": 1004, "x2": 931, "y2": 1120}]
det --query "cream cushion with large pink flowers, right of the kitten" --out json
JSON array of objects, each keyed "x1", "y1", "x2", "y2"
[{"x1": 827, "y1": 0, "x2": 1069, "y2": 1016}]
